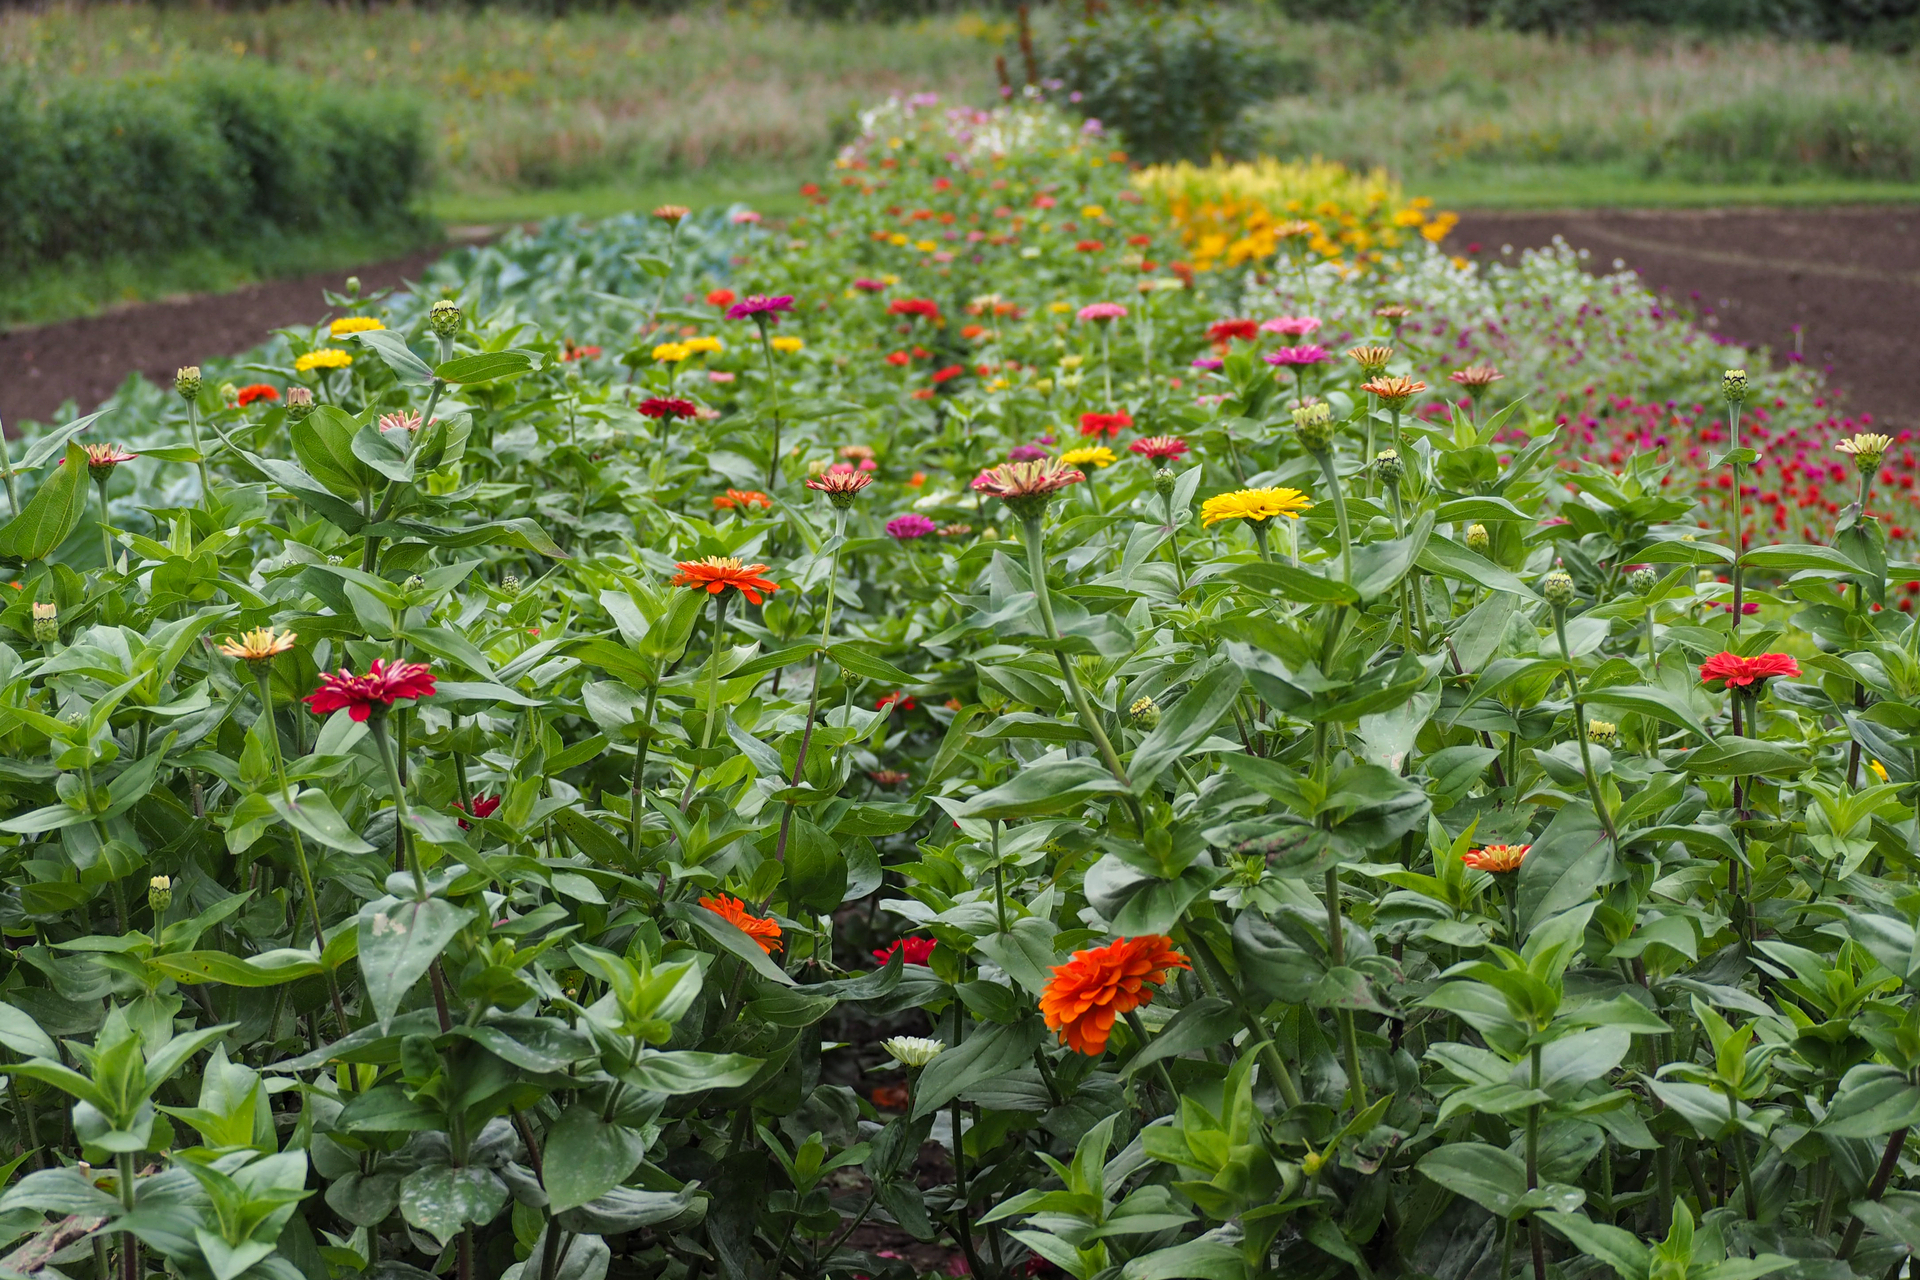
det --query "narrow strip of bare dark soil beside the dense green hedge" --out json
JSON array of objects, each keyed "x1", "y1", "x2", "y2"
[{"x1": 0, "y1": 246, "x2": 449, "y2": 428}]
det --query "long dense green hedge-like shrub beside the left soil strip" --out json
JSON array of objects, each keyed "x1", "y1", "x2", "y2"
[{"x1": 0, "y1": 67, "x2": 428, "y2": 276}]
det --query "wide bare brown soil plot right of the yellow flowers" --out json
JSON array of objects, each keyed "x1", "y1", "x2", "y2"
[{"x1": 1448, "y1": 207, "x2": 1920, "y2": 426}]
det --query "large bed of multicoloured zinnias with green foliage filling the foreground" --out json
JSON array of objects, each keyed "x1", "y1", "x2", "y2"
[{"x1": 0, "y1": 90, "x2": 1920, "y2": 1280}]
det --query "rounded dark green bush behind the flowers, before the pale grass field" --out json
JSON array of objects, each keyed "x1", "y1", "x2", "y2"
[{"x1": 1044, "y1": 8, "x2": 1311, "y2": 161}]
